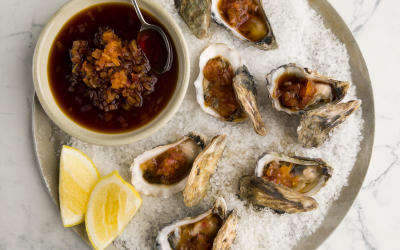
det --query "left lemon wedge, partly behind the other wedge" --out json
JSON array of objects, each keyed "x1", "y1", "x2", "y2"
[{"x1": 59, "y1": 146, "x2": 100, "y2": 227}]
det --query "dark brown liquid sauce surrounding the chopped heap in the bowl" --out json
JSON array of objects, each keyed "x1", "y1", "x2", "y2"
[{"x1": 48, "y1": 3, "x2": 179, "y2": 133}]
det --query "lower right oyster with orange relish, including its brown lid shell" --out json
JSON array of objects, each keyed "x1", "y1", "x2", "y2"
[{"x1": 239, "y1": 152, "x2": 333, "y2": 213}]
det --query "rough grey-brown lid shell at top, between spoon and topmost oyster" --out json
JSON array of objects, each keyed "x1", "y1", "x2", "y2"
[{"x1": 175, "y1": 0, "x2": 211, "y2": 39}]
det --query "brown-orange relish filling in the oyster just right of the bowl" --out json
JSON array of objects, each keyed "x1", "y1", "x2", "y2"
[{"x1": 203, "y1": 57, "x2": 240, "y2": 119}]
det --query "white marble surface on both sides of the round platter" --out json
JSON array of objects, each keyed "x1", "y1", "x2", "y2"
[{"x1": 0, "y1": 0, "x2": 400, "y2": 250}]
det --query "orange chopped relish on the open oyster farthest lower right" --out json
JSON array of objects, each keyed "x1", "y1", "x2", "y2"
[{"x1": 262, "y1": 161, "x2": 300, "y2": 188}]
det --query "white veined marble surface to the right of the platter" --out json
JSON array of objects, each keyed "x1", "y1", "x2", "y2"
[{"x1": 319, "y1": 0, "x2": 400, "y2": 250}]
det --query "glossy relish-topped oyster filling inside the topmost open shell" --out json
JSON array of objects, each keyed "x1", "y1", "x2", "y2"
[{"x1": 218, "y1": 0, "x2": 269, "y2": 42}]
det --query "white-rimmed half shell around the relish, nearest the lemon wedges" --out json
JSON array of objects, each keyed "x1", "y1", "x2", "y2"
[{"x1": 130, "y1": 132, "x2": 206, "y2": 198}]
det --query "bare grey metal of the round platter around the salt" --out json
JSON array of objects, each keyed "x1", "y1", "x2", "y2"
[{"x1": 32, "y1": 0, "x2": 375, "y2": 250}]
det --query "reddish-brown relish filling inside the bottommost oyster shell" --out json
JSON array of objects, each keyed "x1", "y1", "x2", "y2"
[{"x1": 175, "y1": 214, "x2": 222, "y2": 250}]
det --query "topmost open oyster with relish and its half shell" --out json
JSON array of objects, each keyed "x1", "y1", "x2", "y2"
[{"x1": 211, "y1": 0, "x2": 278, "y2": 50}]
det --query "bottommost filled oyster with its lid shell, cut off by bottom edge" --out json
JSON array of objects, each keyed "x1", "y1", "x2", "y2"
[{"x1": 156, "y1": 198, "x2": 237, "y2": 250}]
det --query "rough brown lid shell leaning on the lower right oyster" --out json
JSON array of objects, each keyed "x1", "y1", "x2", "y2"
[{"x1": 239, "y1": 175, "x2": 318, "y2": 213}]
